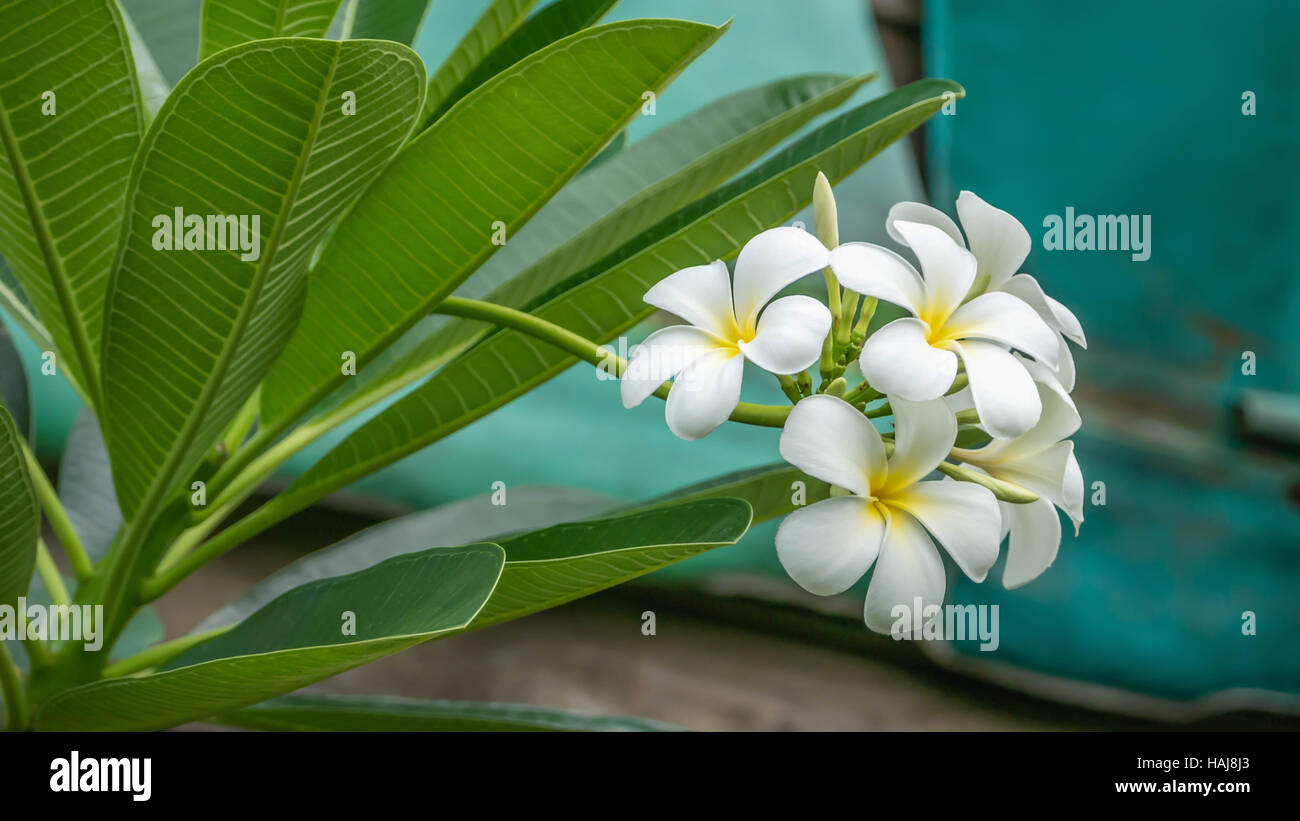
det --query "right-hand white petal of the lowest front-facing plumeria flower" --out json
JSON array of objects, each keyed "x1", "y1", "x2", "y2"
[{"x1": 885, "y1": 482, "x2": 1002, "y2": 582}]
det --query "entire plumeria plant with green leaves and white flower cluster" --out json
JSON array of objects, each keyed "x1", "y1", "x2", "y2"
[{"x1": 0, "y1": 0, "x2": 987, "y2": 730}]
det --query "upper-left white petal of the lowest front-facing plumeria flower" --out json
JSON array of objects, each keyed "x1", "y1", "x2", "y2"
[{"x1": 780, "y1": 394, "x2": 885, "y2": 496}]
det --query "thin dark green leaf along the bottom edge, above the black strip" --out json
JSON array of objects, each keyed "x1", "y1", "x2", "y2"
[{"x1": 212, "y1": 694, "x2": 677, "y2": 733}]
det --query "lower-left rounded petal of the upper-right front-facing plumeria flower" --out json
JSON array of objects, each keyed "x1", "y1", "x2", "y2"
[{"x1": 858, "y1": 317, "x2": 957, "y2": 401}]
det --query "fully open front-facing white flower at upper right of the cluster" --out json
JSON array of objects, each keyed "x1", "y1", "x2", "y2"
[{"x1": 831, "y1": 220, "x2": 1058, "y2": 439}]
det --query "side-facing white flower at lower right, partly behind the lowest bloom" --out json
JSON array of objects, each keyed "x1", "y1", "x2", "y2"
[{"x1": 953, "y1": 362, "x2": 1083, "y2": 590}]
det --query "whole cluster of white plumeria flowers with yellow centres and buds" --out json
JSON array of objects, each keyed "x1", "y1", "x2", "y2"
[{"x1": 621, "y1": 177, "x2": 1086, "y2": 633}]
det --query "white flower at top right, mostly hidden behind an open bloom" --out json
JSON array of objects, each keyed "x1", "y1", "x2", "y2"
[{"x1": 885, "y1": 191, "x2": 1088, "y2": 391}]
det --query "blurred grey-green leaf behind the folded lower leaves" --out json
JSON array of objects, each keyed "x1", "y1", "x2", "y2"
[{"x1": 194, "y1": 487, "x2": 619, "y2": 633}]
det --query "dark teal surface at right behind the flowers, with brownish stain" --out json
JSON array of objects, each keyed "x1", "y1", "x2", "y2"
[{"x1": 926, "y1": 0, "x2": 1300, "y2": 709}]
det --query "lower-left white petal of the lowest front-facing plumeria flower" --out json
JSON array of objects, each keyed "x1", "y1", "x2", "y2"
[{"x1": 776, "y1": 496, "x2": 885, "y2": 596}]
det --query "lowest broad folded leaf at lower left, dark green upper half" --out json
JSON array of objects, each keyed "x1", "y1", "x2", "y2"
[{"x1": 36, "y1": 544, "x2": 504, "y2": 730}]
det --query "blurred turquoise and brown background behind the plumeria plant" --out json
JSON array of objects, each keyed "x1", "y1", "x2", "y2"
[{"x1": 12, "y1": 0, "x2": 1300, "y2": 730}]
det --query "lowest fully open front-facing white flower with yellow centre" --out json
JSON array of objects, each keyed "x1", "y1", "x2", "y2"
[{"x1": 776, "y1": 394, "x2": 1001, "y2": 633}]
